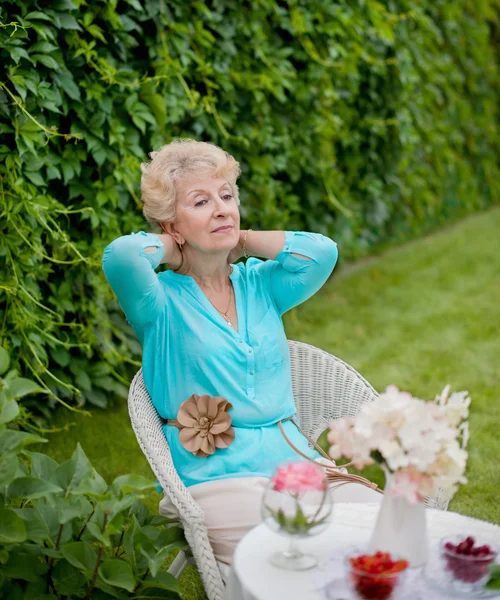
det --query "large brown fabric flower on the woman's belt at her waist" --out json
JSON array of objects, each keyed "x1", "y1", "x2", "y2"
[{"x1": 167, "y1": 394, "x2": 234, "y2": 457}]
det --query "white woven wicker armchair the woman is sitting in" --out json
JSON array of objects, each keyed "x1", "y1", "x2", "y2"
[{"x1": 128, "y1": 341, "x2": 447, "y2": 600}]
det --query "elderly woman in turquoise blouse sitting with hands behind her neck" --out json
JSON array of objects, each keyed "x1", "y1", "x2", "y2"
[{"x1": 103, "y1": 140, "x2": 377, "y2": 563}]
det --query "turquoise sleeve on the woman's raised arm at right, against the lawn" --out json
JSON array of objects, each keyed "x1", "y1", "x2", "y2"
[{"x1": 261, "y1": 231, "x2": 338, "y2": 314}]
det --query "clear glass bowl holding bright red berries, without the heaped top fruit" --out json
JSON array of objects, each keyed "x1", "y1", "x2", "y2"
[{"x1": 345, "y1": 552, "x2": 408, "y2": 600}]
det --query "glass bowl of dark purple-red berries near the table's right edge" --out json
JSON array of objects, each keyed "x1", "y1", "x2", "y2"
[{"x1": 440, "y1": 535, "x2": 497, "y2": 591}]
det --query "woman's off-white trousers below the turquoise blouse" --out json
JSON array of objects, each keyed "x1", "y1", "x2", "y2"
[{"x1": 159, "y1": 477, "x2": 382, "y2": 565}]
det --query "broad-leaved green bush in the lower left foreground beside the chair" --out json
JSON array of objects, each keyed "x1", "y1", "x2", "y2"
[{"x1": 0, "y1": 347, "x2": 186, "y2": 600}]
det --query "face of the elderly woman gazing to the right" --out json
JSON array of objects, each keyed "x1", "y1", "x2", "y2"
[{"x1": 173, "y1": 177, "x2": 240, "y2": 252}]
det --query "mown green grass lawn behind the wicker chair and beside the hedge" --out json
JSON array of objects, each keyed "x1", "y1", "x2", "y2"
[{"x1": 42, "y1": 208, "x2": 500, "y2": 600}]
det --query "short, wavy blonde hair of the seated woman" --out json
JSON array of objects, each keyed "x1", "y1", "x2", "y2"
[{"x1": 141, "y1": 139, "x2": 241, "y2": 227}]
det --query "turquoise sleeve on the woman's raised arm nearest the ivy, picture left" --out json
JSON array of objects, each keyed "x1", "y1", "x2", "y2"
[{"x1": 102, "y1": 231, "x2": 165, "y2": 329}]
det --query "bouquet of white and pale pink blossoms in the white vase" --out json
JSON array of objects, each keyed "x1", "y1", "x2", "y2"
[{"x1": 328, "y1": 385, "x2": 470, "y2": 503}]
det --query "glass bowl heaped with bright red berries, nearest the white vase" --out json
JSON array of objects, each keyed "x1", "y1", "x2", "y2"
[{"x1": 347, "y1": 550, "x2": 408, "y2": 600}]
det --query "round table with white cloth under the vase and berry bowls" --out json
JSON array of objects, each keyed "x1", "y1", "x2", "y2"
[{"x1": 225, "y1": 503, "x2": 500, "y2": 600}]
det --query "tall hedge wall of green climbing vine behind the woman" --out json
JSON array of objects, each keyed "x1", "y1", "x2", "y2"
[{"x1": 0, "y1": 0, "x2": 500, "y2": 426}]
